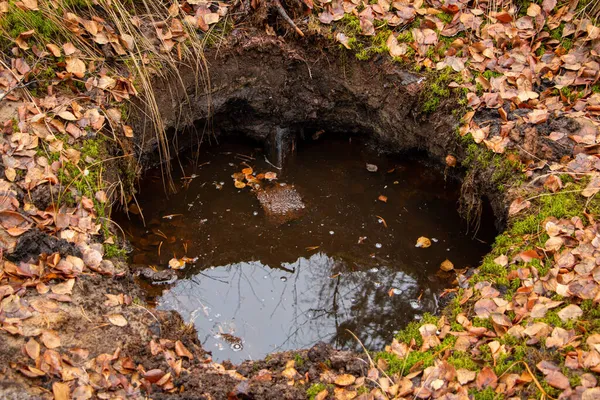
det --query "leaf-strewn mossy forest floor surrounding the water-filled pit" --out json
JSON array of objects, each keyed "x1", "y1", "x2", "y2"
[{"x1": 0, "y1": 0, "x2": 600, "y2": 400}]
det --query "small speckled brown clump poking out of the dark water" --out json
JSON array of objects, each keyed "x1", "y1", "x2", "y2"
[{"x1": 256, "y1": 184, "x2": 306, "y2": 224}]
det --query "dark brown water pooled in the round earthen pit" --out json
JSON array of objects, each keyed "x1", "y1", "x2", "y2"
[{"x1": 117, "y1": 138, "x2": 495, "y2": 362}]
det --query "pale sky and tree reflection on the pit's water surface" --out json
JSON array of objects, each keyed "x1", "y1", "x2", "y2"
[{"x1": 159, "y1": 253, "x2": 436, "y2": 361}]
